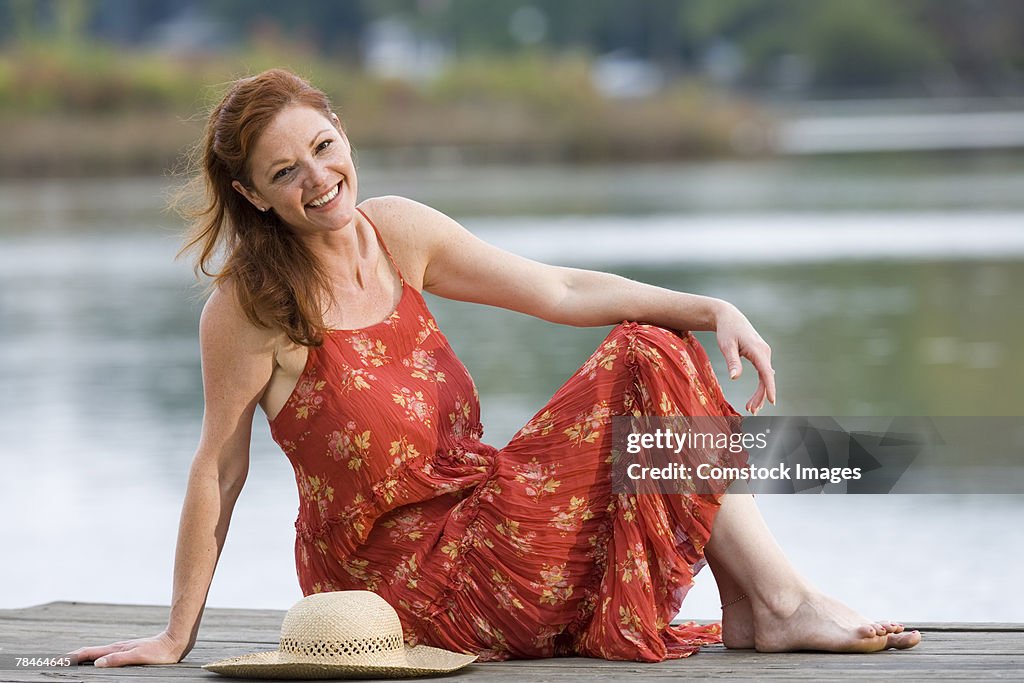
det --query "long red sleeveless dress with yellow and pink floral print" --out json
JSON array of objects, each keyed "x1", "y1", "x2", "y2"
[{"x1": 270, "y1": 211, "x2": 736, "y2": 661}]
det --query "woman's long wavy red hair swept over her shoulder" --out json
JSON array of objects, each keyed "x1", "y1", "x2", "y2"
[{"x1": 179, "y1": 69, "x2": 332, "y2": 346}]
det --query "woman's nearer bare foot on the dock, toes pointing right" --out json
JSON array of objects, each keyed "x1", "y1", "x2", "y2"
[{"x1": 753, "y1": 593, "x2": 921, "y2": 652}]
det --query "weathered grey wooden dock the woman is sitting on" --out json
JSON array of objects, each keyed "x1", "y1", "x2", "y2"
[{"x1": 0, "y1": 602, "x2": 1024, "y2": 683}]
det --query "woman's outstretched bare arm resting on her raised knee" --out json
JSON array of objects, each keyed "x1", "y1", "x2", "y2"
[{"x1": 368, "y1": 198, "x2": 775, "y2": 413}]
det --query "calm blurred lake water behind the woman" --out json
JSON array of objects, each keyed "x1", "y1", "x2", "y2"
[{"x1": 0, "y1": 158, "x2": 1024, "y2": 622}]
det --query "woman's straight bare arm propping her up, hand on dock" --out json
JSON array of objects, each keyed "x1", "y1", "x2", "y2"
[{"x1": 70, "y1": 289, "x2": 274, "y2": 667}]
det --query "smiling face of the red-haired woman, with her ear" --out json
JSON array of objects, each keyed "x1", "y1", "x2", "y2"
[{"x1": 231, "y1": 105, "x2": 357, "y2": 234}]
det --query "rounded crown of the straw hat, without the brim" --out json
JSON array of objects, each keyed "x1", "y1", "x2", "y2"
[{"x1": 281, "y1": 591, "x2": 404, "y2": 663}]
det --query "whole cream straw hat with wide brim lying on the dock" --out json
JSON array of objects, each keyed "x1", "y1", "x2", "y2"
[{"x1": 203, "y1": 591, "x2": 476, "y2": 679}]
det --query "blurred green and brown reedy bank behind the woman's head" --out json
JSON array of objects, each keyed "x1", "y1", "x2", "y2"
[{"x1": 0, "y1": 43, "x2": 774, "y2": 178}]
